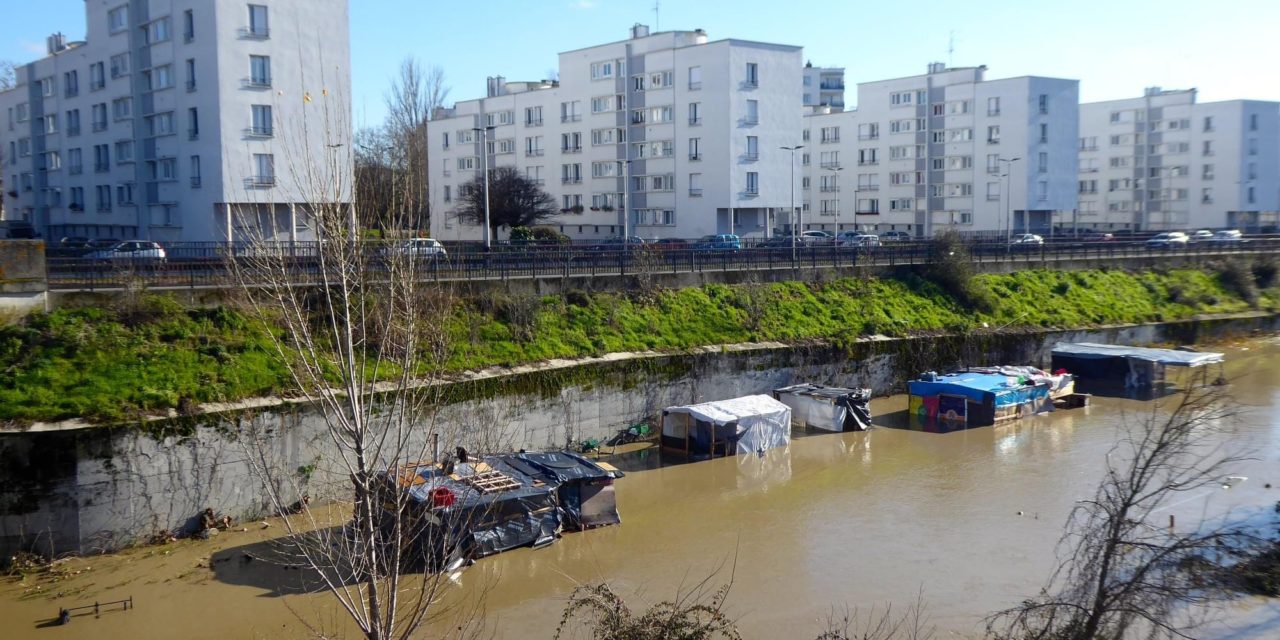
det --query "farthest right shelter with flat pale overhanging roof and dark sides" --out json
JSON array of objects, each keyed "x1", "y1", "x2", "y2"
[{"x1": 1052, "y1": 342, "x2": 1225, "y2": 393}]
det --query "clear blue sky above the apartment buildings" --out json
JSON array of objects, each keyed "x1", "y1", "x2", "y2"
[{"x1": 0, "y1": 0, "x2": 1280, "y2": 124}]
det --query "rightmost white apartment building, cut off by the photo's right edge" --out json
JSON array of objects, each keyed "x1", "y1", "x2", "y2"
[{"x1": 1079, "y1": 87, "x2": 1280, "y2": 232}]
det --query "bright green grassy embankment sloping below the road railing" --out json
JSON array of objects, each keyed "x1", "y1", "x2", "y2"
[{"x1": 0, "y1": 264, "x2": 1280, "y2": 425}]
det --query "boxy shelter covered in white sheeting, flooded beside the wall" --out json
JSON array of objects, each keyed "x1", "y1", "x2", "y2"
[{"x1": 662, "y1": 396, "x2": 791, "y2": 457}]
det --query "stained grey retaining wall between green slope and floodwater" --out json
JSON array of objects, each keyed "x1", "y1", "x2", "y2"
[{"x1": 0, "y1": 315, "x2": 1280, "y2": 554}]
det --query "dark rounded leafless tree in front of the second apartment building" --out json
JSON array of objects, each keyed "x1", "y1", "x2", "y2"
[{"x1": 454, "y1": 166, "x2": 559, "y2": 232}]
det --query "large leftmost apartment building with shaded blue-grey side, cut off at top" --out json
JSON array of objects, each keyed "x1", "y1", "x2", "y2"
[{"x1": 0, "y1": 0, "x2": 351, "y2": 241}]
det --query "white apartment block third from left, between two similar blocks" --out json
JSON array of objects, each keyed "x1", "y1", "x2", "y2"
[{"x1": 800, "y1": 63, "x2": 1079, "y2": 236}]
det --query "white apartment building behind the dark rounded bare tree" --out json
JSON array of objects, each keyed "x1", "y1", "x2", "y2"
[{"x1": 428, "y1": 24, "x2": 804, "y2": 241}]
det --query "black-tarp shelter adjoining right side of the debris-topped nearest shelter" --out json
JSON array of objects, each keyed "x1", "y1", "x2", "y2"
[{"x1": 502, "y1": 452, "x2": 623, "y2": 531}]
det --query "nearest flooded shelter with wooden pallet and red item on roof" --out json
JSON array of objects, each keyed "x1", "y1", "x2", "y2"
[{"x1": 383, "y1": 457, "x2": 561, "y2": 568}]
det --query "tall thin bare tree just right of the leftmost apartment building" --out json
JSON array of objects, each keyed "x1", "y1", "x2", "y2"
[{"x1": 384, "y1": 56, "x2": 449, "y2": 229}]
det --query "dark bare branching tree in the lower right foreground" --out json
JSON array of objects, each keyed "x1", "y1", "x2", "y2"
[{"x1": 987, "y1": 375, "x2": 1244, "y2": 640}]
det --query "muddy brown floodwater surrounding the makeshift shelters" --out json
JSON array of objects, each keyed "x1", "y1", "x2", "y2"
[{"x1": 0, "y1": 339, "x2": 1280, "y2": 640}]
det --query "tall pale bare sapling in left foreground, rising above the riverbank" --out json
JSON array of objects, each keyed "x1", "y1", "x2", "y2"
[{"x1": 229, "y1": 55, "x2": 476, "y2": 640}]
